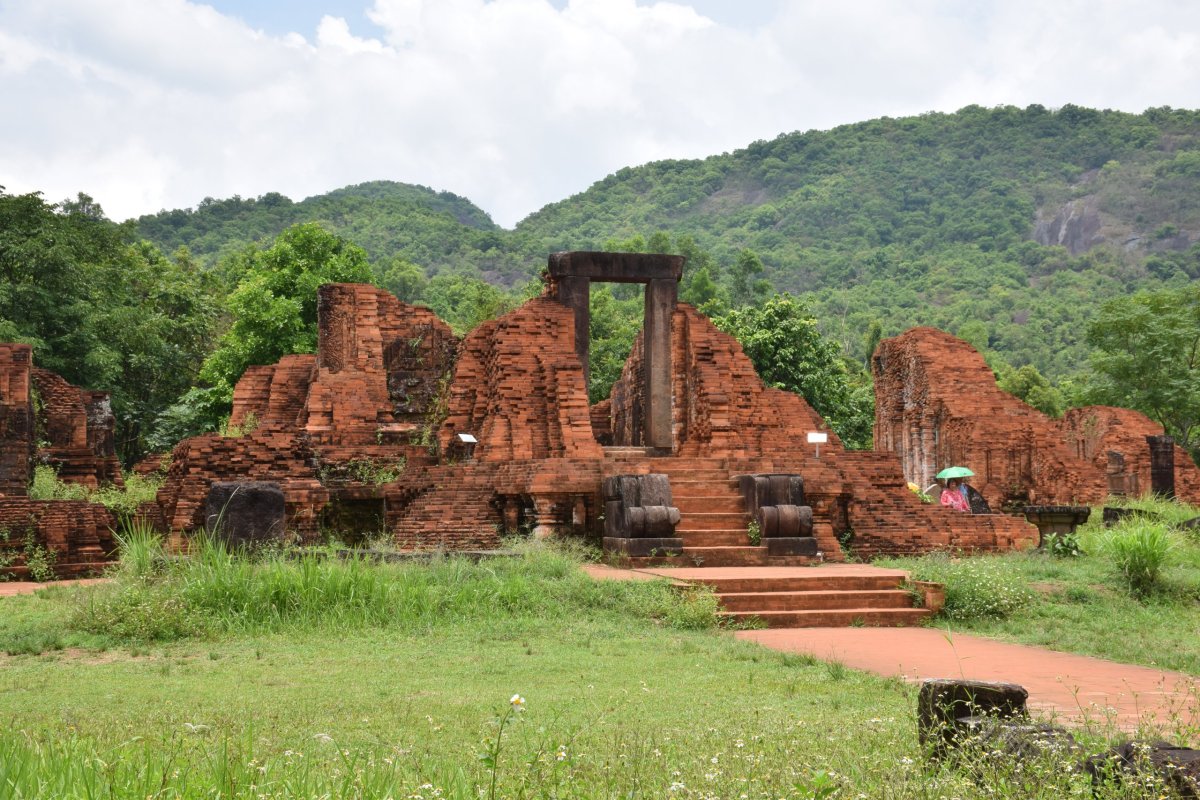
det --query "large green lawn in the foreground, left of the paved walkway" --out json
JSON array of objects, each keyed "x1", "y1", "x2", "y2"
[{"x1": 0, "y1": 542, "x2": 1190, "y2": 800}]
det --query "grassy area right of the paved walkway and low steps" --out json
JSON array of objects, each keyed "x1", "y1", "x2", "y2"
[{"x1": 881, "y1": 499, "x2": 1200, "y2": 675}]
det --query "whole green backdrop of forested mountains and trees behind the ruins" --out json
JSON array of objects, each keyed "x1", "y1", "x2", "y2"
[{"x1": 9, "y1": 106, "x2": 1185, "y2": 463}]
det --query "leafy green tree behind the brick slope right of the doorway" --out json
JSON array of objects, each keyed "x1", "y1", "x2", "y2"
[{"x1": 714, "y1": 294, "x2": 875, "y2": 447}]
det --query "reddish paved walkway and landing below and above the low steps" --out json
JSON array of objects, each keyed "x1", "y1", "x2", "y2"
[{"x1": 588, "y1": 564, "x2": 1200, "y2": 730}]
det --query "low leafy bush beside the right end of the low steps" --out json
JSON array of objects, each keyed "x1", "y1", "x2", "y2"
[{"x1": 910, "y1": 553, "x2": 1033, "y2": 620}]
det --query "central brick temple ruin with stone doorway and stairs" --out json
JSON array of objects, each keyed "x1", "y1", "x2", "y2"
[{"x1": 129, "y1": 252, "x2": 1036, "y2": 566}]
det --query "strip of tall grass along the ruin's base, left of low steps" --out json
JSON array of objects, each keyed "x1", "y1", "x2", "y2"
[{"x1": 71, "y1": 537, "x2": 718, "y2": 640}]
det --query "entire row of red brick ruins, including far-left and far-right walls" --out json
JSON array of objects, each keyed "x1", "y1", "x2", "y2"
[{"x1": 42, "y1": 252, "x2": 1200, "y2": 578}]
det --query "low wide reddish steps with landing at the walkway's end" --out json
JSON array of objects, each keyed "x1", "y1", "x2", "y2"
[{"x1": 644, "y1": 564, "x2": 932, "y2": 627}]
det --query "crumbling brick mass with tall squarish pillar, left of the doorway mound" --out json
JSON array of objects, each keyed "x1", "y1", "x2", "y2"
[{"x1": 154, "y1": 284, "x2": 496, "y2": 547}]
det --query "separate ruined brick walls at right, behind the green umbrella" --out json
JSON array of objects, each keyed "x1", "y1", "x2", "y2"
[{"x1": 872, "y1": 327, "x2": 1200, "y2": 507}]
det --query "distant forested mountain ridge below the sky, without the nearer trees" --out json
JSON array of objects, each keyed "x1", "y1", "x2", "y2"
[{"x1": 138, "y1": 106, "x2": 1200, "y2": 379}]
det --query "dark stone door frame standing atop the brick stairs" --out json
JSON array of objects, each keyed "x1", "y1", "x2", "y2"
[{"x1": 548, "y1": 251, "x2": 685, "y2": 451}]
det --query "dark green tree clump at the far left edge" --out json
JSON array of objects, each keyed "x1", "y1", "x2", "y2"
[{"x1": 0, "y1": 188, "x2": 216, "y2": 463}]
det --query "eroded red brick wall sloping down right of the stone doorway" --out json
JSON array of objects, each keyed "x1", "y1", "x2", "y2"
[{"x1": 611, "y1": 303, "x2": 1037, "y2": 560}]
